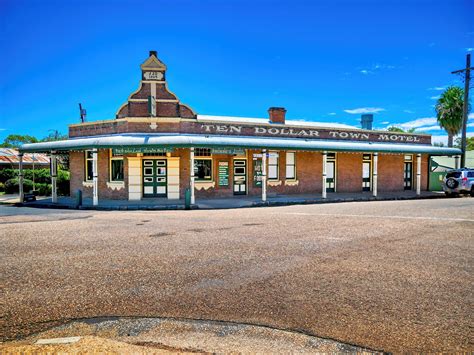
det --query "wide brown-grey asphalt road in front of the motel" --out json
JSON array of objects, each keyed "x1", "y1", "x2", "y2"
[{"x1": 0, "y1": 198, "x2": 474, "y2": 352}]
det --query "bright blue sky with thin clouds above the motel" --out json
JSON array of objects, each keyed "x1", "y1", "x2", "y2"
[{"x1": 0, "y1": 0, "x2": 474, "y2": 145}]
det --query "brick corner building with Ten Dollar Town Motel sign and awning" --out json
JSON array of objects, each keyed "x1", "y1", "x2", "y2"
[{"x1": 20, "y1": 51, "x2": 461, "y2": 205}]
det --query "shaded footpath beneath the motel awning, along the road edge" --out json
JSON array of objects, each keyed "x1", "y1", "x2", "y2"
[{"x1": 0, "y1": 191, "x2": 445, "y2": 210}]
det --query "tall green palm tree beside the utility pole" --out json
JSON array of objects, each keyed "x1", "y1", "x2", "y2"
[{"x1": 435, "y1": 86, "x2": 464, "y2": 147}]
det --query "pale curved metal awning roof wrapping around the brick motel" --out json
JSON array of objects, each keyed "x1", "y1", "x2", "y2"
[{"x1": 20, "y1": 133, "x2": 461, "y2": 155}]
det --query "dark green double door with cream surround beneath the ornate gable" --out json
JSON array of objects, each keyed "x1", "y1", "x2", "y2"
[{"x1": 143, "y1": 159, "x2": 167, "y2": 197}]
